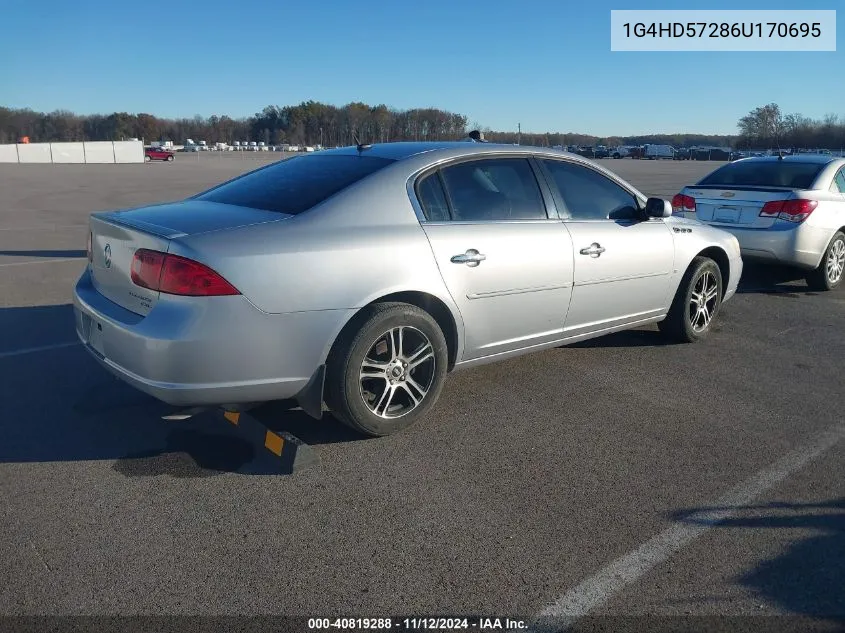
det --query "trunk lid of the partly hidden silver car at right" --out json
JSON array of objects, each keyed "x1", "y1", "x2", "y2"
[{"x1": 684, "y1": 185, "x2": 795, "y2": 229}]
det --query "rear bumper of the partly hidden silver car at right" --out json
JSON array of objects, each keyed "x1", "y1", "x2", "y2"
[{"x1": 708, "y1": 222, "x2": 831, "y2": 269}]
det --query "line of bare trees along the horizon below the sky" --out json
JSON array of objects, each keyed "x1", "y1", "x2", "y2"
[{"x1": 0, "y1": 101, "x2": 845, "y2": 149}]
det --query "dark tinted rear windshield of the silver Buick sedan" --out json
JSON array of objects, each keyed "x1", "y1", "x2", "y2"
[{"x1": 195, "y1": 154, "x2": 394, "y2": 215}]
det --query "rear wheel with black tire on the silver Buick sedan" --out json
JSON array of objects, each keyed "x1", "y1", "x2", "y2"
[{"x1": 325, "y1": 302, "x2": 449, "y2": 437}]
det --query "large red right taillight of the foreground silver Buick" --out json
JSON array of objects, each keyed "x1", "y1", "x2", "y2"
[{"x1": 132, "y1": 248, "x2": 240, "y2": 297}]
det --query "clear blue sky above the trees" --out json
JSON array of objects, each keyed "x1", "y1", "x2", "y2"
[{"x1": 0, "y1": 0, "x2": 845, "y2": 136}]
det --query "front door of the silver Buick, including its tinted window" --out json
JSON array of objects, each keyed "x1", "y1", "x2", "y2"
[{"x1": 541, "y1": 159, "x2": 675, "y2": 336}]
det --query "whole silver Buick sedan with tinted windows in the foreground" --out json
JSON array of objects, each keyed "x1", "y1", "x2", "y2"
[{"x1": 74, "y1": 142, "x2": 742, "y2": 436}]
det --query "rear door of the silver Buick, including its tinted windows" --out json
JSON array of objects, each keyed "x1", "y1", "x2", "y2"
[{"x1": 417, "y1": 157, "x2": 573, "y2": 360}]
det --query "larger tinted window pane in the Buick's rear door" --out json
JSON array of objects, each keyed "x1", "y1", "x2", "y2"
[{"x1": 441, "y1": 158, "x2": 548, "y2": 222}]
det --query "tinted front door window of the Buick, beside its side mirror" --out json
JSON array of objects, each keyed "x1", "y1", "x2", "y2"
[{"x1": 543, "y1": 160, "x2": 640, "y2": 220}]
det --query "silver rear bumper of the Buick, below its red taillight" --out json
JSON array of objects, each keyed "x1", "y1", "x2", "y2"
[{"x1": 74, "y1": 271, "x2": 347, "y2": 406}]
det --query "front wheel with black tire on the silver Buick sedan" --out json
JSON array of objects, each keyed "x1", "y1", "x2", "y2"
[{"x1": 657, "y1": 256, "x2": 722, "y2": 343}]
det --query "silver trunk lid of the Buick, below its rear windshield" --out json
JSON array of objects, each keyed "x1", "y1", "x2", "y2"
[{"x1": 88, "y1": 200, "x2": 293, "y2": 316}]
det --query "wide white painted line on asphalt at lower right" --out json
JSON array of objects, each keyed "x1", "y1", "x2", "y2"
[{"x1": 531, "y1": 424, "x2": 845, "y2": 632}]
